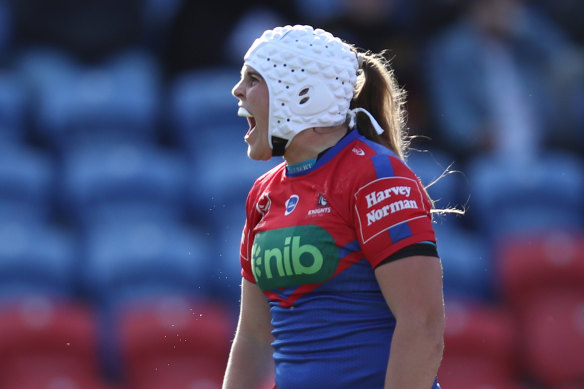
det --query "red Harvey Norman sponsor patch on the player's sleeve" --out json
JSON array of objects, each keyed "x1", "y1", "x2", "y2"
[{"x1": 355, "y1": 177, "x2": 427, "y2": 243}]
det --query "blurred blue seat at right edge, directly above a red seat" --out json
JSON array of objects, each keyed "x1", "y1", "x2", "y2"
[{"x1": 466, "y1": 152, "x2": 584, "y2": 244}]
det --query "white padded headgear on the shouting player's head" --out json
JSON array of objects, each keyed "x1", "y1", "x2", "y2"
[{"x1": 244, "y1": 26, "x2": 359, "y2": 153}]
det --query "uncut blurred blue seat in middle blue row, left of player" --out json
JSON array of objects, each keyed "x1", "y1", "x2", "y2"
[{"x1": 60, "y1": 143, "x2": 187, "y2": 228}]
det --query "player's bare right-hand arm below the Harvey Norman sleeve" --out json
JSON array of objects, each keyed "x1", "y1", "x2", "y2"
[{"x1": 375, "y1": 256, "x2": 444, "y2": 389}]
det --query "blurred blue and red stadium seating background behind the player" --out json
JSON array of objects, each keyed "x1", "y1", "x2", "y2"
[{"x1": 0, "y1": 0, "x2": 584, "y2": 389}]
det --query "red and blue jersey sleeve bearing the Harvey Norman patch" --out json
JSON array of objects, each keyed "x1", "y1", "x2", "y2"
[{"x1": 354, "y1": 155, "x2": 436, "y2": 267}]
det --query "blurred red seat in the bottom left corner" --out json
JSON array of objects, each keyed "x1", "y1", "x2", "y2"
[{"x1": 0, "y1": 297, "x2": 101, "y2": 389}]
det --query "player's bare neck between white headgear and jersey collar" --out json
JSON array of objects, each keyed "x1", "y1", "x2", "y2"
[{"x1": 284, "y1": 125, "x2": 347, "y2": 165}]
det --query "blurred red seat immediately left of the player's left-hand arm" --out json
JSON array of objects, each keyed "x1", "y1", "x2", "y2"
[{"x1": 118, "y1": 299, "x2": 235, "y2": 389}]
